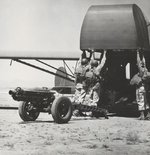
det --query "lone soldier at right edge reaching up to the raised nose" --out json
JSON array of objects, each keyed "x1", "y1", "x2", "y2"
[{"x1": 130, "y1": 51, "x2": 150, "y2": 120}]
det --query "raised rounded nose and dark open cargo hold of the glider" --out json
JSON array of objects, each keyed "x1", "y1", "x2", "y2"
[{"x1": 80, "y1": 4, "x2": 150, "y2": 113}]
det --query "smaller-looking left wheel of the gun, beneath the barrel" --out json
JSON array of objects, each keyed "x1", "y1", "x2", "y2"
[{"x1": 19, "y1": 101, "x2": 40, "y2": 121}]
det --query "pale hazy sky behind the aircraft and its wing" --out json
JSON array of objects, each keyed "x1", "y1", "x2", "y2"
[{"x1": 0, "y1": 0, "x2": 150, "y2": 87}]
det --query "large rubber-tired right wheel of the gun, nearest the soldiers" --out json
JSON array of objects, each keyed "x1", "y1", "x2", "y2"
[{"x1": 51, "y1": 96, "x2": 72, "y2": 124}]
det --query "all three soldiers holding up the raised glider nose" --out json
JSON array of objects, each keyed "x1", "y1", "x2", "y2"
[{"x1": 74, "y1": 50, "x2": 150, "y2": 120}]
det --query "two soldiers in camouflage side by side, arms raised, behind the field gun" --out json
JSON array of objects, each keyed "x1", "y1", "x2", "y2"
[{"x1": 75, "y1": 51, "x2": 106, "y2": 115}]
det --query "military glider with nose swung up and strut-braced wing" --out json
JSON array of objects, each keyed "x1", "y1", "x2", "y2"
[{"x1": 0, "y1": 4, "x2": 150, "y2": 121}]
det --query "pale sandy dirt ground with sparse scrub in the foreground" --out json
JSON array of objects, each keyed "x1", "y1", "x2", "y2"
[{"x1": 0, "y1": 110, "x2": 150, "y2": 155}]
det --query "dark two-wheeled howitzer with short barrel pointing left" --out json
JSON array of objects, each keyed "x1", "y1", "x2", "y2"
[{"x1": 9, "y1": 87, "x2": 108, "y2": 123}]
